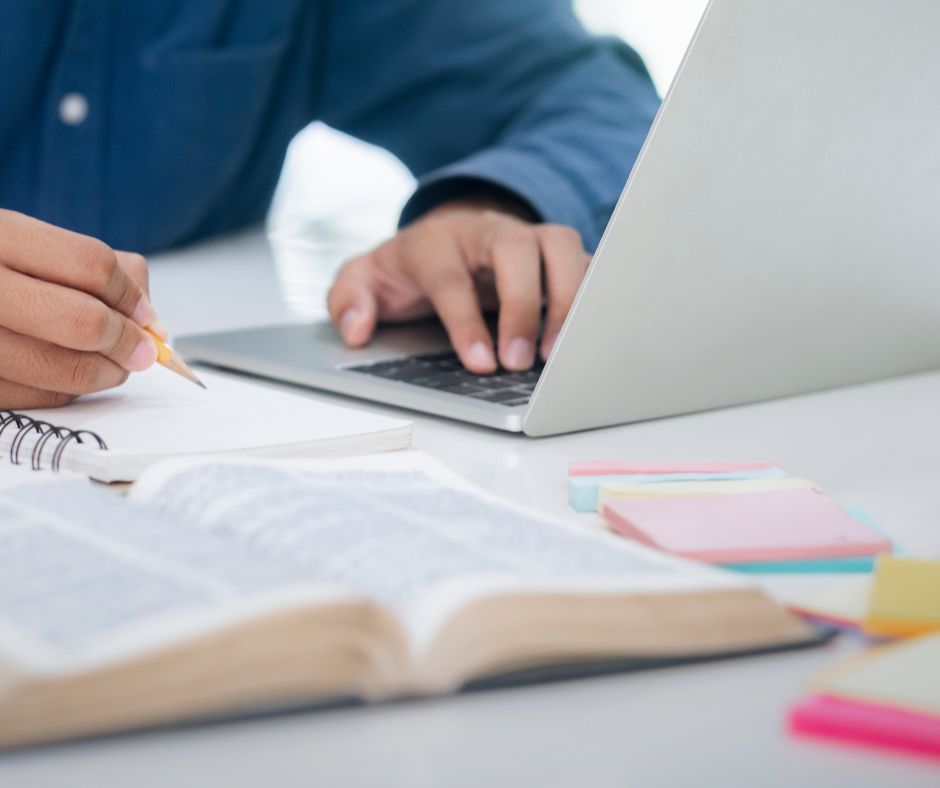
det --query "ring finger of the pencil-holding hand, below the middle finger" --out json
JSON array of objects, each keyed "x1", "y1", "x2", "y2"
[{"x1": 0, "y1": 328, "x2": 127, "y2": 403}]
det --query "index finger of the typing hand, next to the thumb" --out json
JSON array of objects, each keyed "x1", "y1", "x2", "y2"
[{"x1": 399, "y1": 228, "x2": 496, "y2": 375}]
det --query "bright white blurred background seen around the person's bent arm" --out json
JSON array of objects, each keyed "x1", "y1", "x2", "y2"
[{"x1": 268, "y1": 0, "x2": 707, "y2": 319}]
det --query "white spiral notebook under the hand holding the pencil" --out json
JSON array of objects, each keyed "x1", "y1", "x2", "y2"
[{"x1": 0, "y1": 367, "x2": 411, "y2": 482}]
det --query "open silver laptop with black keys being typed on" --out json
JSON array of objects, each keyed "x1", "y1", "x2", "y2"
[{"x1": 177, "y1": 0, "x2": 940, "y2": 436}]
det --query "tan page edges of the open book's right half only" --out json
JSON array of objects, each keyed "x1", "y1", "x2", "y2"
[{"x1": 420, "y1": 587, "x2": 816, "y2": 693}]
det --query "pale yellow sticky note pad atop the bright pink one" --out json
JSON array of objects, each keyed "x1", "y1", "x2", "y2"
[{"x1": 812, "y1": 632, "x2": 940, "y2": 718}]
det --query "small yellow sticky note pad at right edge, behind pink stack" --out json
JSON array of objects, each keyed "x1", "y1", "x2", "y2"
[{"x1": 862, "y1": 555, "x2": 940, "y2": 637}]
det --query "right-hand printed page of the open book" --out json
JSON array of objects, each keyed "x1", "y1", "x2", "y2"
[{"x1": 131, "y1": 452, "x2": 742, "y2": 652}]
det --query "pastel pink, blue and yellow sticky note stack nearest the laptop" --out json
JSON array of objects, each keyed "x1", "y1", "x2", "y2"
[{"x1": 568, "y1": 462, "x2": 892, "y2": 572}]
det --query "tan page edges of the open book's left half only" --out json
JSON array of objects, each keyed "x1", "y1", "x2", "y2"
[{"x1": 0, "y1": 601, "x2": 409, "y2": 749}]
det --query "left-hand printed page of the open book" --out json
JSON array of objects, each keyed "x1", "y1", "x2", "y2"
[{"x1": 0, "y1": 471, "x2": 341, "y2": 670}]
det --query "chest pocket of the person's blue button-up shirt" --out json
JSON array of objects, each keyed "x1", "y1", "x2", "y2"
[{"x1": 128, "y1": 37, "x2": 290, "y2": 247}]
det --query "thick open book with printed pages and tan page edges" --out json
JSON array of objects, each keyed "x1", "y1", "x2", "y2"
[{"x1": 0, "y1": 452, "x2": 818, "y2": 747}]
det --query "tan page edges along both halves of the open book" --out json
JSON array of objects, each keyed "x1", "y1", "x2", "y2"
[{"x1": 0, "y1": 587, "x2": 814, "y2": 749}]
